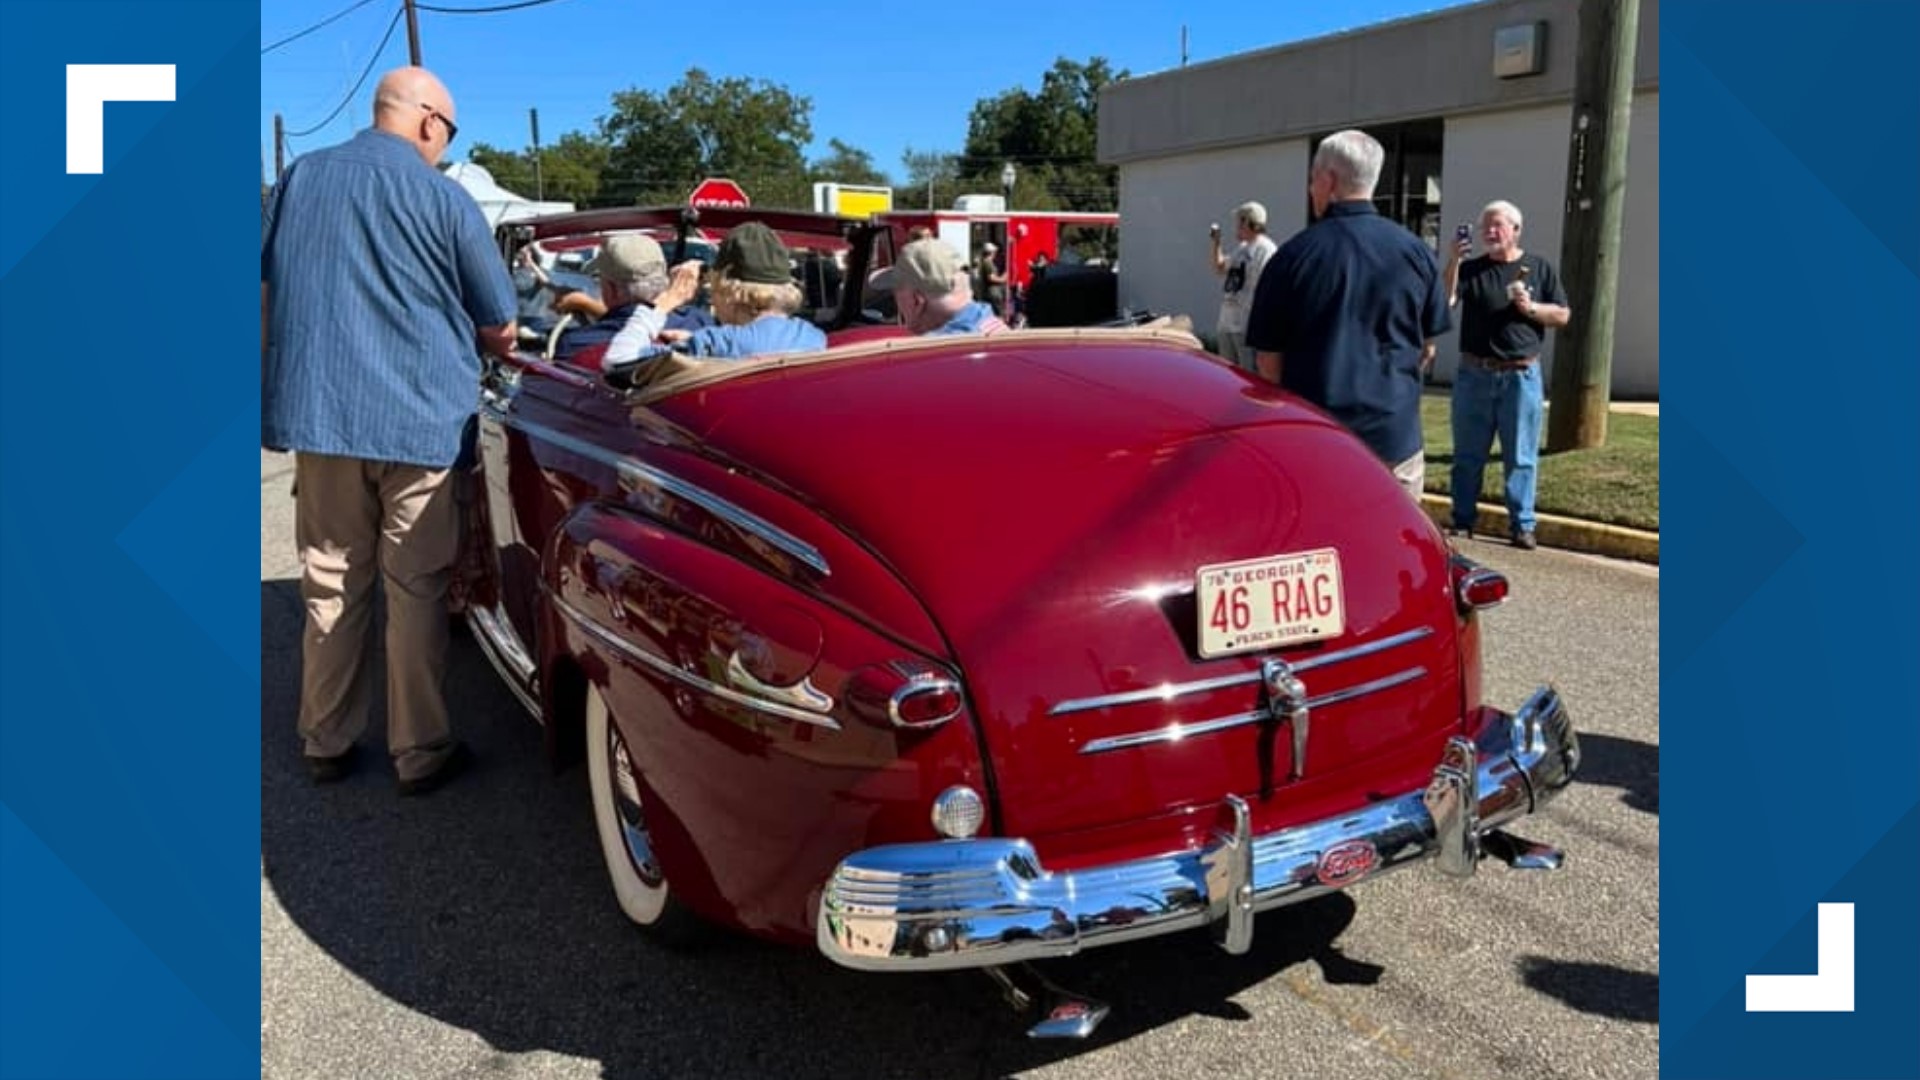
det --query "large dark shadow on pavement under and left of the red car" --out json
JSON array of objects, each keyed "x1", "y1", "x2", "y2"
[{"x1": 261, "y1": 580, "x2": 1382, "y2": 1078}]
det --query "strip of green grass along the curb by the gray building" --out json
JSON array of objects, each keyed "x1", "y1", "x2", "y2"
[{"x1": 1421, "y1": 390, "x2": 1661, "y2": 532}]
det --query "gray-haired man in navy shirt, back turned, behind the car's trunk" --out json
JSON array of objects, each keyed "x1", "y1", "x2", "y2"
[{"x1": 1246, "y1": 131, "x2": 1453, "y2": 500}]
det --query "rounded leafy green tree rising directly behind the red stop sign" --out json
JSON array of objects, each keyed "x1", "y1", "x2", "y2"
[{"x1": 599, "y1": 67, "x2": 814, "y2": 208}]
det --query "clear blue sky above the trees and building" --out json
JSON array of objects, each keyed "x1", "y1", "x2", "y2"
[{"x1": 259, "y1": 0, "x2": 1459, "y2": 194}]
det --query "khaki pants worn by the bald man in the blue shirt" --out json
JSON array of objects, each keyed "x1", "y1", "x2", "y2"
[{"x1": 294, "y1": 454, "x2": 461, "y2": 780}]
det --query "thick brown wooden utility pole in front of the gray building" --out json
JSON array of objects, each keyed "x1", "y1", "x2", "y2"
[{"x1": 1548, "y1": 0, "x2": 1640, "y2": 454}]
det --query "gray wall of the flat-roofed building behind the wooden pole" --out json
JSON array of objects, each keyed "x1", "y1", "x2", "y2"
[{"x1": 1100, "y1": 0, "x2": 1659, "y2": 398}]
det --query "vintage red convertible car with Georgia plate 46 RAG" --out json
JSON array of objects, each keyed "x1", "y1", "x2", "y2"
[{"x1": 465, "y1": 209, "x2": 1580, "y2": 1036}]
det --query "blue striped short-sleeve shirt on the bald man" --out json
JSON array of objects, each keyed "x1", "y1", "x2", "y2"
[{"x1": 259, "y1": 129, "x2": 515, "y2": 469}]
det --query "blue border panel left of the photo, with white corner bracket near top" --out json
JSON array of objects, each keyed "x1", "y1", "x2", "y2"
[{"x1": 0, "y1": 0, "x2": 261, "y2": 1076}]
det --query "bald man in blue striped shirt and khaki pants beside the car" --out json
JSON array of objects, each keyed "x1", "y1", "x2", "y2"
[{"x1": 259, "y1": 67, "x2": 516, "y2": 796}]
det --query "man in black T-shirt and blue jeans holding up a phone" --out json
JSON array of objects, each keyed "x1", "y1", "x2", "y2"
[{"x1": 1446, "y1": 200, "x2": 1572, "y2": 552}]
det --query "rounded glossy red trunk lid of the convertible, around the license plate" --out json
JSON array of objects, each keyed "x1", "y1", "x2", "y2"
[{"x1": 662, "y1": 338, "x2": 1459, "y2": 836}]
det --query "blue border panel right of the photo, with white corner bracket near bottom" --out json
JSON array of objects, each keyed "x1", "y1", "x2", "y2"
[{"x1": 1661, "y1": 0, "x2": 1920, "y2": 1078}]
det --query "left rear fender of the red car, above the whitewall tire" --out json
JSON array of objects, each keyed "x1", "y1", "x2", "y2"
[{"x1": 541, "y1": 505, "x2": 991, "y2": 942}]
